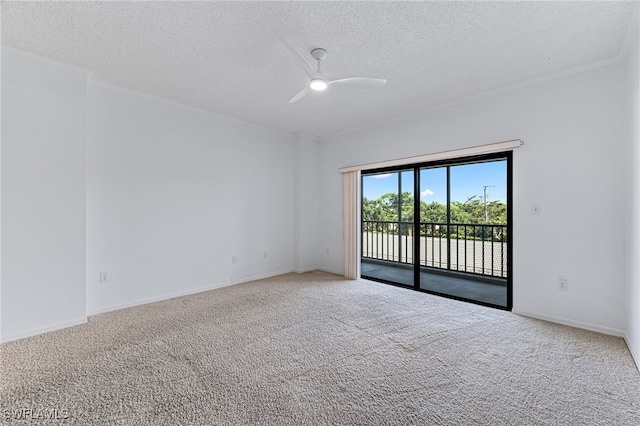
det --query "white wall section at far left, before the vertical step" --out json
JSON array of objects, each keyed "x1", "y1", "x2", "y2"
[{"x1": 0, "y1": 48, "x2": 86, "y2": 341}]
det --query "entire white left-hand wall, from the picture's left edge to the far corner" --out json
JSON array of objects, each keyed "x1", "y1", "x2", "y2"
[{"x1": 0, "y1": 49, "x2": 298, "y2": 341}]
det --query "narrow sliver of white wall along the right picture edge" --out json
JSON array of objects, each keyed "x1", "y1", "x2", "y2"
[{"x1": 625, "y1": 9, "x2": 640, "y2": 366}]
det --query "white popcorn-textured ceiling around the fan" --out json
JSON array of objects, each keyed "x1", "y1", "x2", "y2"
[{"x1": 1, "y1": 1, "x2": 637, "y2": 136}]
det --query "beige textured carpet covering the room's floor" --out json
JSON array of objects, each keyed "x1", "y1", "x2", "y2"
[{"x1": 0, "y1": 272, "x2": 640, "y2": 425}]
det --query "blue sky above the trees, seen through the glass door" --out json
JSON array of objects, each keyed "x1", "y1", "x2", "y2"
[{"x1": 362, "y1": 161, "x2": 507, "y2": 204}]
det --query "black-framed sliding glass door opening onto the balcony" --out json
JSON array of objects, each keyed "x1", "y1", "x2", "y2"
[{"x1": 361, "y1": 153, "x2": 511, "y2": 309}]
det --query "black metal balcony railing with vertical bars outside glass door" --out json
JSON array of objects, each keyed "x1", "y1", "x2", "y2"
[{"x1": 361, "y1": 220, "x2": 507, "y2": 278}]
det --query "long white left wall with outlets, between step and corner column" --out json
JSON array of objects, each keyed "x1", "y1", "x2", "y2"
[{"x1": 86, "y1": 81, "x2": 295, "y2": 313}]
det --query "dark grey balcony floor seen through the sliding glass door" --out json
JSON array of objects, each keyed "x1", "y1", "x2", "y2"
[{"x1": 361, "y1": 259, "x2": 507, "y2": 307}]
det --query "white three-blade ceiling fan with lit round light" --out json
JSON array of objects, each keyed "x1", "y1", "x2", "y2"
[{"x1": 278, "y1": 37, "x2": 387, "y2": 104}]
